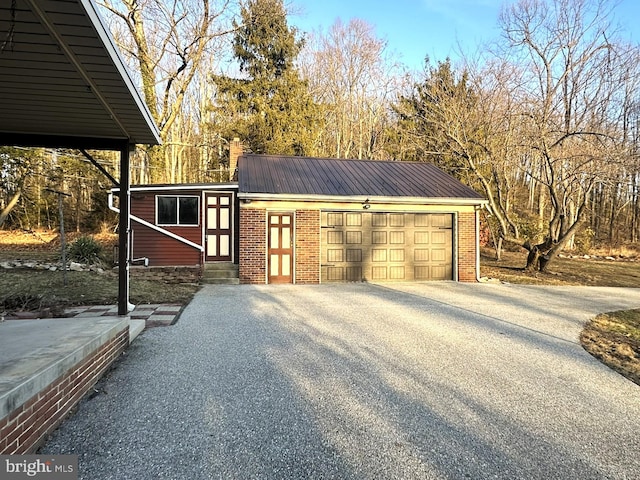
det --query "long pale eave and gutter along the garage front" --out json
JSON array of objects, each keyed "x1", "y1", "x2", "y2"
[{"x1": 238, "y1": 192, "x2": 488, "y2": 206}]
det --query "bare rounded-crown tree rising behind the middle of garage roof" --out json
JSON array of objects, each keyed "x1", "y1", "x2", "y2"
[{"x1": 301, "y1": 19, "x2": 400, "y2": 158}]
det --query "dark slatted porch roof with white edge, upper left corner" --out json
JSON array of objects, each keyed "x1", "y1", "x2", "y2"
[{"x1": 0, "y1": 0, "x2": 160, "y2": 148}]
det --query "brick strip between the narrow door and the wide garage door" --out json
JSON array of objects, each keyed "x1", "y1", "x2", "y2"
[{"x1": 295, "y1": 210, "x2": 320, "y2": 283}]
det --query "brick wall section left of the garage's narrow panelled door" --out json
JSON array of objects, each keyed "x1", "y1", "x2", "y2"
[{"x1": 239, "y1": 208, "x2": 267, "y2": 284}]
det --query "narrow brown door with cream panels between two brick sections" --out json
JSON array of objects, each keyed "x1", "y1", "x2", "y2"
[{"x1": 267, "y1": 213, "x2": 293, "y2": 283}]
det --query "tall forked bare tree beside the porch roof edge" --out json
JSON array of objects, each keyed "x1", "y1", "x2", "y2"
[{"x1": 101, "y1": 0, "x2": 236, "y2": 182}]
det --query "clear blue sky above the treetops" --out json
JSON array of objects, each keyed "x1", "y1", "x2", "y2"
[{"x1": 285, "y1": 0, "x2": 640, "y2": 69}]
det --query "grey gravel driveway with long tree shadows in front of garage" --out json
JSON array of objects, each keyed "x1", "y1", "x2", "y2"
[{"x1": 41, "y1": 282, "x2": 640, "y2": 480}]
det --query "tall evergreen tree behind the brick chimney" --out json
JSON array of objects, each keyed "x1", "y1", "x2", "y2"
[{"x1": 213, "y1": 0, "x2": 319, "y2": 155}]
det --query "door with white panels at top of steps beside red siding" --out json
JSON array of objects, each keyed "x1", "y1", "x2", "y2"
[{"x1": 204, "y1": 192, "x2": 233, "y2": 262}]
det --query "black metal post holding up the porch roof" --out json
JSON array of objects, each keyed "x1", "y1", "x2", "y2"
[{"x1": 118, "y1": 145, "x2": 130, "y2": 315}]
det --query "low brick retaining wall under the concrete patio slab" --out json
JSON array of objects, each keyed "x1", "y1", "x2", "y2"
[{"x1": 0, "y1": 327, "x2": 129, "y2": 455}]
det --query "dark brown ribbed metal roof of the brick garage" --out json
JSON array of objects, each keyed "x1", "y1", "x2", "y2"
[{"x1": 238, "y1": 155, "x2": 484, "y2": 204}]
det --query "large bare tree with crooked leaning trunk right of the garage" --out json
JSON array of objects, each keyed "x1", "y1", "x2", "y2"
[{"x1": 500, "y1": 0, "x2": 628, "y2": 270}]
